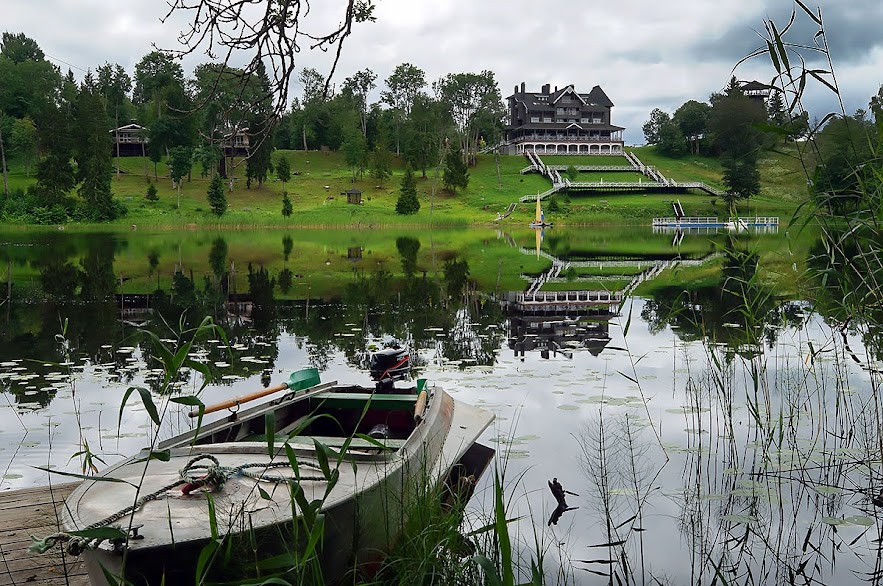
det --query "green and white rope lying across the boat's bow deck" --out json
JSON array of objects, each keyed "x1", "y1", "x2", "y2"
[{"x1": 28, "y1": 454, "x2": 327, "y2": 556}]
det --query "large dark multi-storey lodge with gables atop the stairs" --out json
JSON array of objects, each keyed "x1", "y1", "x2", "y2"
[{"x1": 506, "y1": 83, "x2": 625, "y2": 155}]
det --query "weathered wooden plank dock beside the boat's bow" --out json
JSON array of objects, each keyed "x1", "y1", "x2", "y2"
[{"x1": 0, "y1": 483, "x2": 89, "y2": 586}]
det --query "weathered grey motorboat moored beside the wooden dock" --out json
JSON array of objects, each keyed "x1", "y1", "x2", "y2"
[{"x1": 63, "y1": 369, "x2": 494, "y2": 584}]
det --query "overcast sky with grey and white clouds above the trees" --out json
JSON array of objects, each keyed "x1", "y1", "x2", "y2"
[{"x1": 0, "y1": 0, "x2": 883, "y2": 144}]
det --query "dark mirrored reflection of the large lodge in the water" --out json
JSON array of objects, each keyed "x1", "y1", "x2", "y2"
[{"x1": 509, "y1": 306, "x2": 617, "y2": 358}]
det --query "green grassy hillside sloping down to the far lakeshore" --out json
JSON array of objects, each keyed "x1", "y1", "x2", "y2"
[{"x1": 1, "y1": 147, "x2": 806, "y2": 227}]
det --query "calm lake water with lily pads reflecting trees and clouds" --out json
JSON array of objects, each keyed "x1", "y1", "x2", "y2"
[{"x1": 0, "y1": 230, "x2": 881, "y2": 584}]
